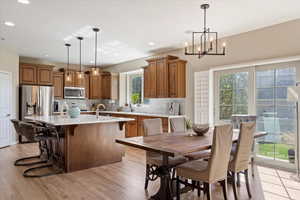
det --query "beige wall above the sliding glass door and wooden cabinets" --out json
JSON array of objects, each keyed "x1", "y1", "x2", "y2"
[{"x1": 107, "y1": 19, "x2": 300, "y2": 118}]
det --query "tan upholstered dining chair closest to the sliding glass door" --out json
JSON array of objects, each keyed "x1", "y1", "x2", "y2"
[{"x1": 228, "y1": 122, "x2": 256, "y2": 200}]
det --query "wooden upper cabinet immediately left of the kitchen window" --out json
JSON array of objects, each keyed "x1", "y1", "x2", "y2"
[{"x1": 101, "y1": 72, "x2": 119, "y2": 99}]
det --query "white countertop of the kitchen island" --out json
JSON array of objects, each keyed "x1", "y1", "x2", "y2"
[{"x1": 25, "y1": 114, "x2": 135, "y2": 126}]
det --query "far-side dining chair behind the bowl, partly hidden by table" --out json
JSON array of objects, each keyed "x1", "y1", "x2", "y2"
[{"x1": 170, "y1": 117, "x2": 210, "y2": 160}]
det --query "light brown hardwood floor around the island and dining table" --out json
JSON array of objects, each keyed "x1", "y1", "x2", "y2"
[{"x1": 0, "y1": 144, "x2": 264, "y2": 200}]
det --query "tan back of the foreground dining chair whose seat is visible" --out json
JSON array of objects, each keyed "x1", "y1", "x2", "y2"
[{"x1": 208, "y1": 124, "x2": 233, "y2": 182}]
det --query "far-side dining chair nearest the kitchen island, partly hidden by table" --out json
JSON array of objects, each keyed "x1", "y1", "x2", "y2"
[{"x1": 143, "y1": 118, "x2": 187, "y2": 190}]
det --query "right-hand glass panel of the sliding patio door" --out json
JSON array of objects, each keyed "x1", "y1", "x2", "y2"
[{"x1": 256, "y1": 67, "x2": 296, "y2": 163}]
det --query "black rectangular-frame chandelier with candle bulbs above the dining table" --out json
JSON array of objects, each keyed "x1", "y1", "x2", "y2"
[{"x1": 184, "y1": 4, "x2": 226, "y2": 58}]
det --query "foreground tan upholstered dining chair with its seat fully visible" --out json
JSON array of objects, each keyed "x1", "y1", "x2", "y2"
[{"x1": 176, "y1": 124, "x2": 233, "y2": 200}]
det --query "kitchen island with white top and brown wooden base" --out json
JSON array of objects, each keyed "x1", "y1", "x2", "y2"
[{"x1": 26, "y1": 115, "x2": 134, "y2": 172}]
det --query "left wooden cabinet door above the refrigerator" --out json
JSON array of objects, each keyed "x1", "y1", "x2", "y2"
[{"x1": 20, "y1": 64, "x2": 37, "y2": 85}]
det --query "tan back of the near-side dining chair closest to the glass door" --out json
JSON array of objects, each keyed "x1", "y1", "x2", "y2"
[{"x1": 230, "y1": 122, "x2": 256, "y2": 172}]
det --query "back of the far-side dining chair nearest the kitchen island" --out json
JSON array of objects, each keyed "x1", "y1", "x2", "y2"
[{"x1": 143, "y1": 118, "x2": 163, "y2": 136}]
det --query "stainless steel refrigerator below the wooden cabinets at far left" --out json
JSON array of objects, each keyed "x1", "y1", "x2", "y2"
[{"x1": 19, "y1": 85, "x2": 54, "y2": 143}]
